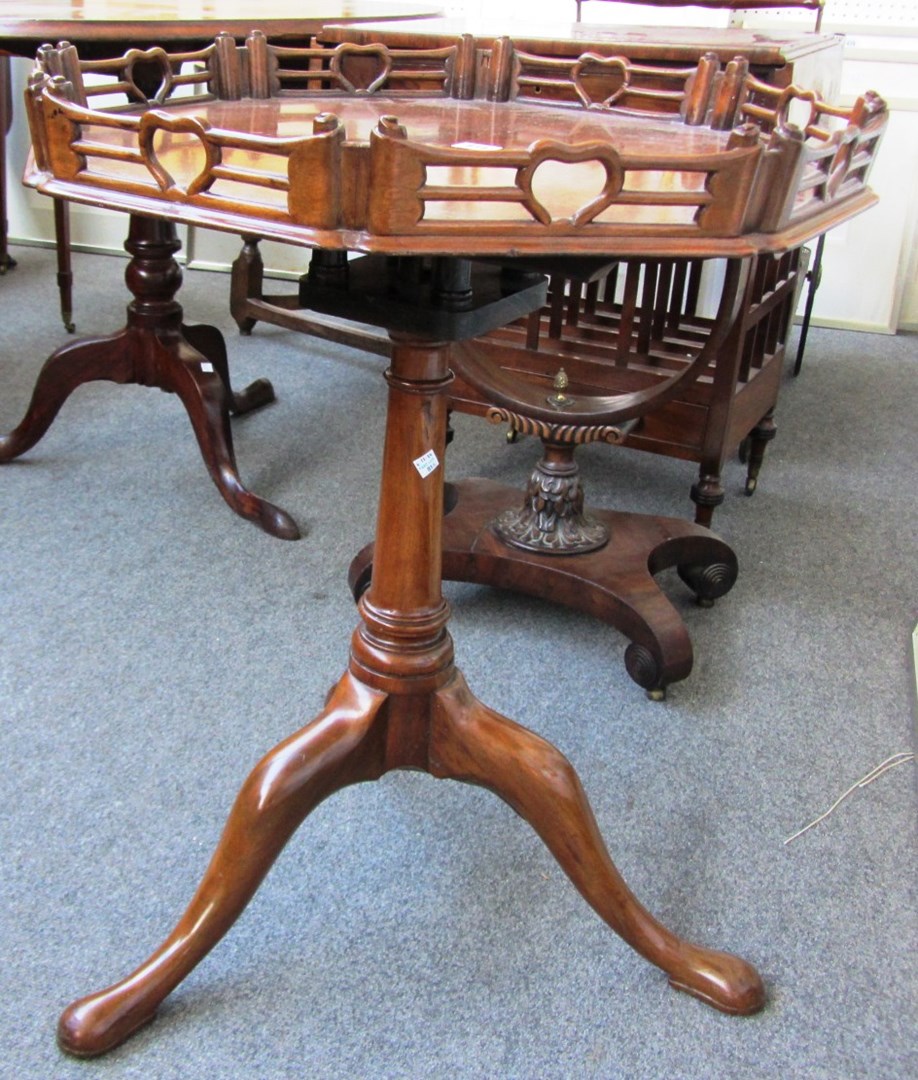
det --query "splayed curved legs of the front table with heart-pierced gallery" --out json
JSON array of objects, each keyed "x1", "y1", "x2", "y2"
[{"x1": 58, "y1": 663, "x2": 765, "y2": 1056}]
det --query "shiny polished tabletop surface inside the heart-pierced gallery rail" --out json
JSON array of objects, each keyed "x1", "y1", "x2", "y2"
[{"x1": 76, "y1": 94, "x2": 730, "y2": 234}]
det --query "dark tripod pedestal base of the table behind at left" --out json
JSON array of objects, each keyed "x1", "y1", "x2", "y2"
[{"x1": 0, "y1": 216, "x2": 299, "y2": 540}]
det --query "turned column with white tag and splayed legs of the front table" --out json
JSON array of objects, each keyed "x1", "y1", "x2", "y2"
[{"x1": 58, "y1": 332, "x2": 764, "y2": 1056}]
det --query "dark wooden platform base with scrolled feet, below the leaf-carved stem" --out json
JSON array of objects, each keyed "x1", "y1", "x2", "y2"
[{"x1": 350, "y1": 480, "x2": 737, "y2": 699}]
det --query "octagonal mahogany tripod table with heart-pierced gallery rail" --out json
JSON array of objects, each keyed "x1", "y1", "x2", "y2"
[{"x1": 17, "y1": 35, "x2": 882, "y2": 1055}]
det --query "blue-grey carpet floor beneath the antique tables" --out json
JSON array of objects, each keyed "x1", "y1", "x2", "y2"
[{"x1": 0, "y1": 248, "x2": 918, "y2": 1080}]
